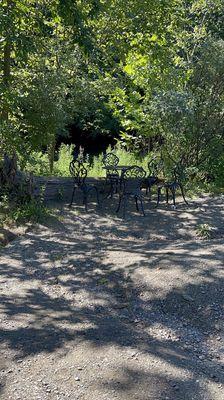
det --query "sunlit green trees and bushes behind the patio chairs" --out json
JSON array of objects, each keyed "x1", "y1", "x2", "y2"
[{"x1": 0, "y1": 0, "x2": 224, "y2": 191}]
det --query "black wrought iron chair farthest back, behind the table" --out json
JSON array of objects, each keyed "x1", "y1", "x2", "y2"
[{"x1": 103, "y1": 153, "x2": 120, "y2": 198}]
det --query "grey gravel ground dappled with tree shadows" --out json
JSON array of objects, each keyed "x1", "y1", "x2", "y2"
[{"x1": 0, "y1": 193, "x2": 224, "y2": 400}]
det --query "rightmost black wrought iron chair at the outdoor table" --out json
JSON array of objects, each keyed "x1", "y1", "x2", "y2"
[{"x1": 156, "y1": 165, "x2": 188, "y2": 207}]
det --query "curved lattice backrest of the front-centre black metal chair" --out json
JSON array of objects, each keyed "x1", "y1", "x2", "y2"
[{"x1": 122, "y1": 165, "x2": 146, "y2": 193}]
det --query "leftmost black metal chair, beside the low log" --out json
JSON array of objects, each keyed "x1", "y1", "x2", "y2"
[{"x1": 69, "y1": 160, "x2": 99, "y2": 211}]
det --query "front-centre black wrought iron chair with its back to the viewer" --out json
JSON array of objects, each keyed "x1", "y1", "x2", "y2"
[{"x1": 116, "y1": 166, "x2": 146, "y2": 218}]
